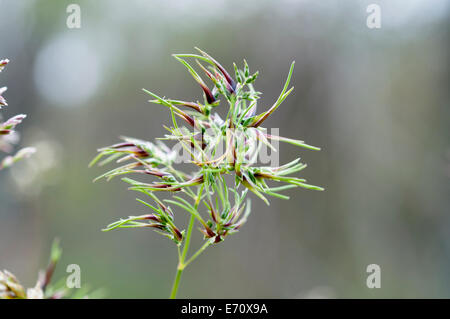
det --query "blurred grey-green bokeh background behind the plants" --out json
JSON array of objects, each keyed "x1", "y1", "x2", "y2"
[{"x1": 0, "y1": 0, "x2": 450, "y2": 298}]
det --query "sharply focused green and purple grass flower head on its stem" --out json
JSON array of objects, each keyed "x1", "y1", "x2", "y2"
[{"x1": 90, "y1": 49, "x2": 323, "y2": 298}]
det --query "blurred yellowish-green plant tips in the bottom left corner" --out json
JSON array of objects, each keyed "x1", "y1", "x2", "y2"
[{"x1": 0, "y1": 240, "x2": 93, "y2": 299}]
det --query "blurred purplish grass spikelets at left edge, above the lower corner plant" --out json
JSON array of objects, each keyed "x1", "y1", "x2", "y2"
[{"x1": 0, "y1": 59, "x2": 36, "y2": 170}]
